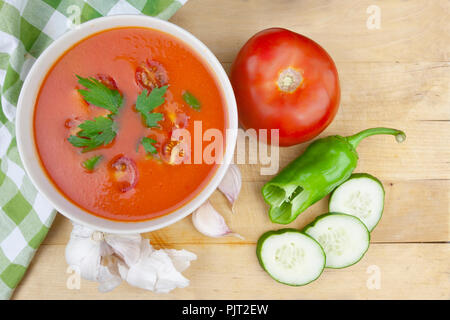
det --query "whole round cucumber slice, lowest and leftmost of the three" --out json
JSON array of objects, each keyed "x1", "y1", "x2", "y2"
[{"x1": 256, "y1": 229, "x2": 325, "y2": 286}]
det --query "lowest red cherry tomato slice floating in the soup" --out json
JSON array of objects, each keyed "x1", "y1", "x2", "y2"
[{"x1": 110, "y1": 155, "x2": 139, "y2": 192}]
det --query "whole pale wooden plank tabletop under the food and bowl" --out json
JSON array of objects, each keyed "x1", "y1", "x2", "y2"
[{"x1": 14, "y1": 0, "x2": 450, "y2": 299}]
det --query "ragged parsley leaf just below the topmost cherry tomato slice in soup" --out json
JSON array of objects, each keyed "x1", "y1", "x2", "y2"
[{"x1": 136, "y1": 86, "x2": 168, "y2": 128}]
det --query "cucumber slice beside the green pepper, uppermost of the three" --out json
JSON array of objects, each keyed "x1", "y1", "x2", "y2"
[{"x1": 329, "y1": 173, "x2": 384, "y2": 231}]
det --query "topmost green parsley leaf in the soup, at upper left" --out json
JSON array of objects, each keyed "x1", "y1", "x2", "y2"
[{"x1": 77, "y1": 75, "x2": 123, "y2": 114}]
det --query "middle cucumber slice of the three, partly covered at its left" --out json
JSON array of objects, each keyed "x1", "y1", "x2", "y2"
[{"x1": 304, "y1": 213, "x2": 370, "y2": 269}]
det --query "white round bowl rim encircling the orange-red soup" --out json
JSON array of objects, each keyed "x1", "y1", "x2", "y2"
[{"x1": 16, "y1": 15, "x2": 238, "y2": 233}]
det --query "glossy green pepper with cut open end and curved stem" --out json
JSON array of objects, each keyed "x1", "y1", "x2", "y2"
[{"x1": 262, "y1": 128, "x2": 406, "y2": 224}]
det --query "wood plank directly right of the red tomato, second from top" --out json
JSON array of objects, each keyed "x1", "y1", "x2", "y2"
[{"x1": 223, "y1": 62, "x2": 450, "y2": 121}]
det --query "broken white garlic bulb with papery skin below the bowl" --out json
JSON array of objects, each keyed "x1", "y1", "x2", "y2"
[{"x1": 66, "y1": 223, "x2": 197, "y2": 293}]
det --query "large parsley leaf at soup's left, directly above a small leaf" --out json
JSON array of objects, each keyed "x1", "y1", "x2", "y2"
[{"x1": 68, "y1": 117, "x2": 116, "y2": 152}]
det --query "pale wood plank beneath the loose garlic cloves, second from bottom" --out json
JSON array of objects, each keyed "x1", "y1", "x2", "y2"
[{"x1": 44, "y1": 180, "x2": 450, "y2": 247}]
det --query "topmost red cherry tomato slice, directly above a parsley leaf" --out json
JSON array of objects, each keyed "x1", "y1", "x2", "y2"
[{"x1": 135, "y1": 60, "x2": 169, "y2": 92}]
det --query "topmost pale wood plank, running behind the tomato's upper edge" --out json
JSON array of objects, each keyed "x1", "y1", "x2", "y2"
[{"x1": 171, "y1": 0, "x2": 450, "y2": 62}]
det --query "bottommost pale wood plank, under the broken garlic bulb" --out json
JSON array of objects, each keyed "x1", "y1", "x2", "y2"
[{"x1": 13, "y1": 244, "x2": 450, "y2": 300}]
